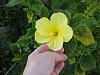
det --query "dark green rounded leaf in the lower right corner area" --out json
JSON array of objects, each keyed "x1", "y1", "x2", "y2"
[{"x1": 79, "y1": 55, "x2": 96, "y2": 71}]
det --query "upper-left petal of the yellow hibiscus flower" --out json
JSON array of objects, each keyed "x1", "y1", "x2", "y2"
[{"x1": 36, "y1": 17, "x2": 55, "y2": 36}]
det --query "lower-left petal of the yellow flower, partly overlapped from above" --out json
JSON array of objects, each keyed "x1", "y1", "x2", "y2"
[{"x1": 35, "y1": 31, "x2": 51, "y2": 43}]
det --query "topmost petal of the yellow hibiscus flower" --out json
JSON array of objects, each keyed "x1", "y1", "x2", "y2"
[{"x1": 50, "y1": 12, "x2": 68, "y2": 30}]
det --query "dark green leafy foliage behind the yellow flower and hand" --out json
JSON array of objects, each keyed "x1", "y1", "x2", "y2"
[{"x1": 0, "y1": 0, "x2": 100, "y2": 75}]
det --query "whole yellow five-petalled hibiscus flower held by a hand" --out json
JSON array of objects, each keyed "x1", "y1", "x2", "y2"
[{"x1": 35, "y1": 12, "x2": 73, "y2": 51}]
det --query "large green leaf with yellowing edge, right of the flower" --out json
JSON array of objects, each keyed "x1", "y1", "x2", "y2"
[{"x1": 74, "y1": 25, "x2": 95, "y2": 45}]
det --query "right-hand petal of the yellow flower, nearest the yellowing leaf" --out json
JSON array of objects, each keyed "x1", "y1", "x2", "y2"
[{"x1": 61, "y1": 25, "x2": 73, "y2": 42}]
